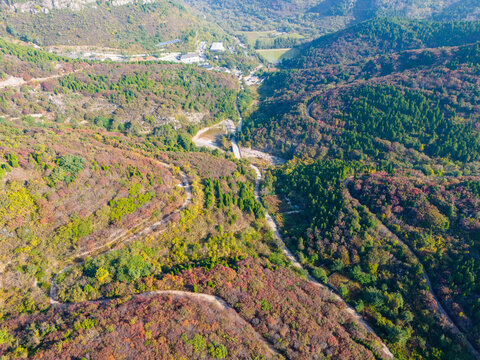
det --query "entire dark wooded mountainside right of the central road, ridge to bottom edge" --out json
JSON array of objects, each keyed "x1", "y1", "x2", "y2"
[{"x1": 240, "y1": 15, "x2": 480, "y2": 359}]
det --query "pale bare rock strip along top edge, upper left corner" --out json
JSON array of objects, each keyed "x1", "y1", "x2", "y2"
[{"x1": 3, "y1": 0, "x2": 155, "y2": 13}]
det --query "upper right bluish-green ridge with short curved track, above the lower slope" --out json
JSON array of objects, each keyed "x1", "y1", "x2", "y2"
[{"x1": 240, "y1": 19, "x2": 480, "y2": 161}]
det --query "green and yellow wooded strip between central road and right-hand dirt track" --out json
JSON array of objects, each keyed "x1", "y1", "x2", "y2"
[{"x1": 267, "y1": 161, "x2": 469, "y2": 359}]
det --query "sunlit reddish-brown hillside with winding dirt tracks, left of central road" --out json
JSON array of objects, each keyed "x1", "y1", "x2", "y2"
[{"x1": 0, "y1": 42, "x2": 387, "y2": 360}]
